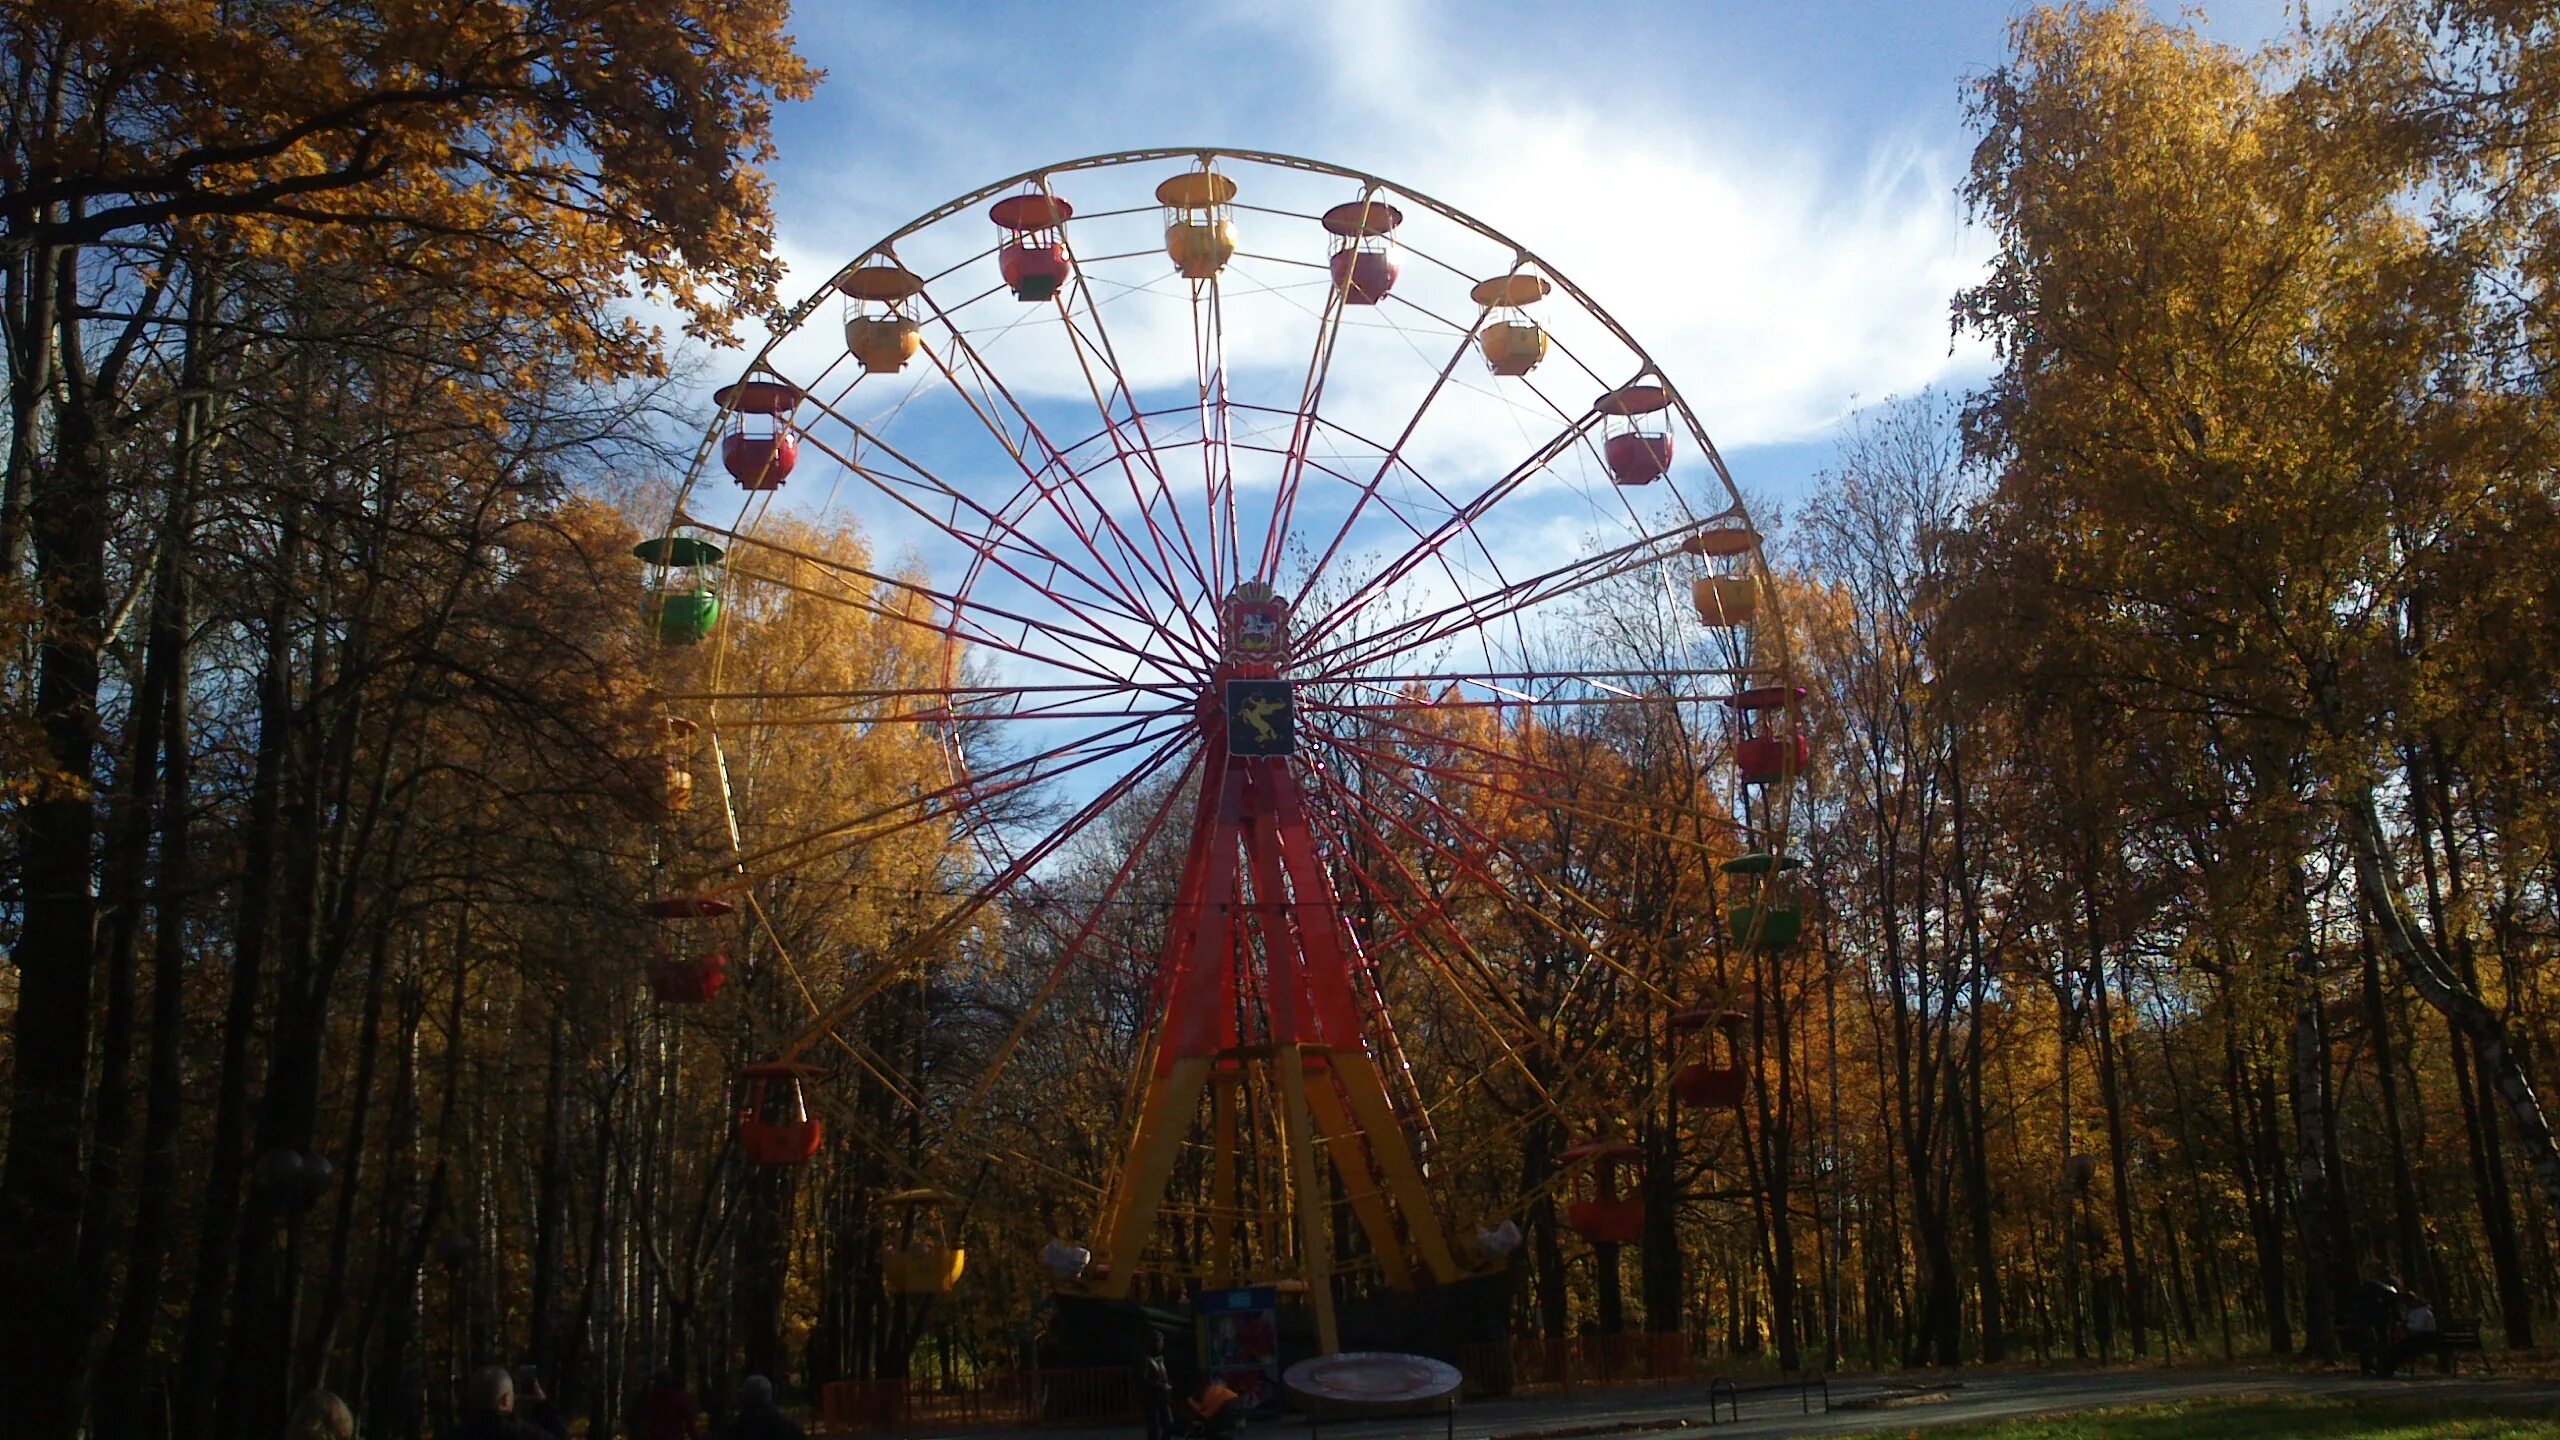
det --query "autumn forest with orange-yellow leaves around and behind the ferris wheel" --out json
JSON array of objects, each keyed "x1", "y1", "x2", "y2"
[{"x1": 0, "y1": 0, "x2": 2560, "y2": 1440}]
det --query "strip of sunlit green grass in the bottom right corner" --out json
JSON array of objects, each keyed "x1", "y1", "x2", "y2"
[{"x1": 1910, "y1": 1396, "x2": 2560, "y2": 1440}]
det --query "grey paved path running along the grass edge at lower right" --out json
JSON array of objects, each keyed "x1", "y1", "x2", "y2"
[{"x1": 924, "y1": 1371, "x2": 2560, "y2": 1440}]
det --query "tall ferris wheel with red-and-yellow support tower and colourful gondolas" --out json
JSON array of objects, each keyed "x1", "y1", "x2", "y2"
[{"x1": 640, "y1": 149, "x2": 1810, "y2": 1350}]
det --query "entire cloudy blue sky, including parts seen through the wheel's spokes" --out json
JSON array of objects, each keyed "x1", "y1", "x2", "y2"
[{"x1": 634, "y1": 0, "x2": 2304, "y2": 871}]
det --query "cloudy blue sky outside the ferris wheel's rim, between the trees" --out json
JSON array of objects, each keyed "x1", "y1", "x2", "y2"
[{"x1": 709, "y1": 0, "x2": 2334, "y2": 507}]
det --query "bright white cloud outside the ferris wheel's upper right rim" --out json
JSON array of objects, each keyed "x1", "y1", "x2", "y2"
[{"x1": 1231, "y1": 0, "x2": 1989, "y2": 448}]
